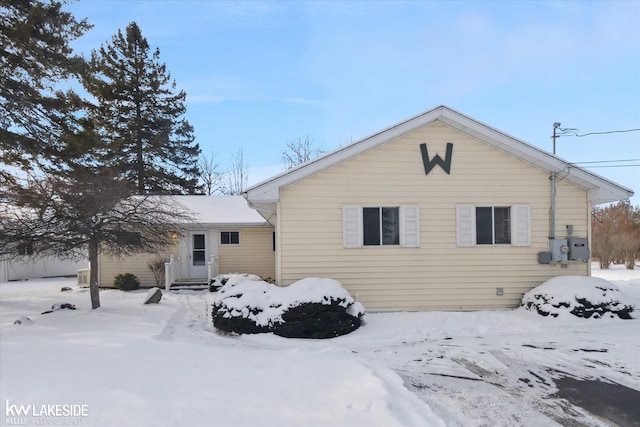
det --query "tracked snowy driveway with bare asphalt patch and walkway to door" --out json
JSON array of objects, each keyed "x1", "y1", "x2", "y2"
[{"x1": 150, "y1": 272, "x2": 640, "y2": 426}]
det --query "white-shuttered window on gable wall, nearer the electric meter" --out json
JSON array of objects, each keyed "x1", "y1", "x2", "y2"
[{"x1": 456, "y1": 205, "x2": 531, "y2": 246}]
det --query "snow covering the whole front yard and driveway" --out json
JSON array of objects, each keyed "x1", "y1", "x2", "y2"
[{"x1": 0, "y1": 264, "x2": 640, "y2": 426}]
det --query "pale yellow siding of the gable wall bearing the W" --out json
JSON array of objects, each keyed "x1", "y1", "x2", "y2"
[{"x1": 278, "y1": 122, "x2": 589, "y2": 309}]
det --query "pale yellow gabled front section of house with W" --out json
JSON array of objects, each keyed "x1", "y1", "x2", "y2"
[{"x1": 243, "y1": 106, "x2": 633, "y2": 309}]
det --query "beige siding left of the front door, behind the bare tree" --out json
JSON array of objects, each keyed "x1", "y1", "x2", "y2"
[{"x1": 100, "y1": 244, "x2": 179, "y2": 288}]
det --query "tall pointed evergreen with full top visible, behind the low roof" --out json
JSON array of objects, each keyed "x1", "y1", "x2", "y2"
[{"x1": 85, "y1": 22, "x2": 200, "y2": 194}]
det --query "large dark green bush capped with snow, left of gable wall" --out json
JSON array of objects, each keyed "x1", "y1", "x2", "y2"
[{"x1": 212, "y1": 275, "x2": 364, "y2": 338}]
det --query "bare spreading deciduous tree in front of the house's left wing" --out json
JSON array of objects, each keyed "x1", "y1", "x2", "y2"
[{"x1": 0, "y1": 168, "x2": 191, "y2": 308}]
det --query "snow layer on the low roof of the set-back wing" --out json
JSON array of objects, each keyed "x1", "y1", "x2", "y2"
[{"x1": 168, "y1": 196, "x2": 266, "y2": 226}]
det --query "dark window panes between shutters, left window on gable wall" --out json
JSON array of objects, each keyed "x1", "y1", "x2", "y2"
[{"x1": 362, "y1": 207, "x2": 400, "y2": 246}]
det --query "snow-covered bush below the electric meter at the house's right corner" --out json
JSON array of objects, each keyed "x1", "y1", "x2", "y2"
[{"x1": 521, "y1": 276, "x2": 634, "y2": 319}]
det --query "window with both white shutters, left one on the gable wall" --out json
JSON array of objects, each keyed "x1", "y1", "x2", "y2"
[{"x1": 342, "y1": 205, "x2": 420, "y2": 248}]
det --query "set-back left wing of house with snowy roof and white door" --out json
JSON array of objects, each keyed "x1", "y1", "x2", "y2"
[{"x1": 98, "y1": 196, "x2": 275, "y2": 288}]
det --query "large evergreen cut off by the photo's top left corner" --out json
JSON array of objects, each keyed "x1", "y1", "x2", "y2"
[{"x1": 0, "y1": 0, "x2": 91, "y2": 177}]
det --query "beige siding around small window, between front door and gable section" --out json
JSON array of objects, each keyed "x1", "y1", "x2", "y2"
[{"x1": 218, "y1": 227, "x2": 275, "y2": 279}]
